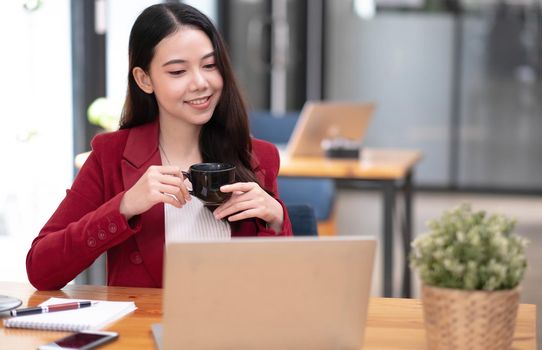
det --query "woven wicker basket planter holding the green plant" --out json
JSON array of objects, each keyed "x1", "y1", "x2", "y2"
[{"x1": 422, "y1": 285, "x2": 520, "y2": 350}]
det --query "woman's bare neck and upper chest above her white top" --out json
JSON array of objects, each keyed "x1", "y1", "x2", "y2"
[{"x1": 159, "y1": 118, "x2": 202, "y2": 169}]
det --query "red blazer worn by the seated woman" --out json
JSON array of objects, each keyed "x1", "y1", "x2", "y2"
[{"x1": 26, "y1": 122, "x2": 292, "y2": 290}]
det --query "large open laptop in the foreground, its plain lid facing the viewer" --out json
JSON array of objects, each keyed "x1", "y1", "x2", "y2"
[{"x1": 159, "y1": 236, "x2": 376, "y2": 350}]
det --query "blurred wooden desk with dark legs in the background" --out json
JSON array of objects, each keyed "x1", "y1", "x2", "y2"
[{"x1": 279, "y1": 148, "x2": 422, "y2": 297}]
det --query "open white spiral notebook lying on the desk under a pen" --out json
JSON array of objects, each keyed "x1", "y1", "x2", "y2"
[{"x1": 4, "y1": 298, "x2": 137, "y2": 332}]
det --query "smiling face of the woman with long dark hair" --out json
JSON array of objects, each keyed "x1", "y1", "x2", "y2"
[{"x1": 142, "y1": 27, "x2": 223, "y2": 125}]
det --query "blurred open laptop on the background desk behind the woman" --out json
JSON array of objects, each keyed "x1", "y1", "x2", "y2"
[{"x1": 284, "y1": 101, "x2": 375, "y2": 158}]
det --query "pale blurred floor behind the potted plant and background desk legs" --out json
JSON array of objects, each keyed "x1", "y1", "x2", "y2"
[{"x1": 336, "y1": 189, "x2": 542, "y2": 344}]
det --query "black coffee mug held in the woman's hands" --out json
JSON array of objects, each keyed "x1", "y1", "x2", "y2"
[{"x1": 182, "y1": 163, "x2": 235, "y2": 206}]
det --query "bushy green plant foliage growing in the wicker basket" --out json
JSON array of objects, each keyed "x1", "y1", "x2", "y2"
[{"x1": 410, "y1": 204, "x2": 528, "y2": 291}]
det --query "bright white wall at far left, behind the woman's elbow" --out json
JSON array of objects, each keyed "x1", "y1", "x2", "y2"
[{"x1": 0, "y1": 0, "x2": 73, "y2": 281}]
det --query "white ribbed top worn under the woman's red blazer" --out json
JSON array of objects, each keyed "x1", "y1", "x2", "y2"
[{"x1": 164, "y1": 196, "x2": 231, "y2": 244}]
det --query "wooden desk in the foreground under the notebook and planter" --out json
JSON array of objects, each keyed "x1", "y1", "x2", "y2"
[{"x1": 0, "y1": 282, "x2": 536, "y2": 350}]
